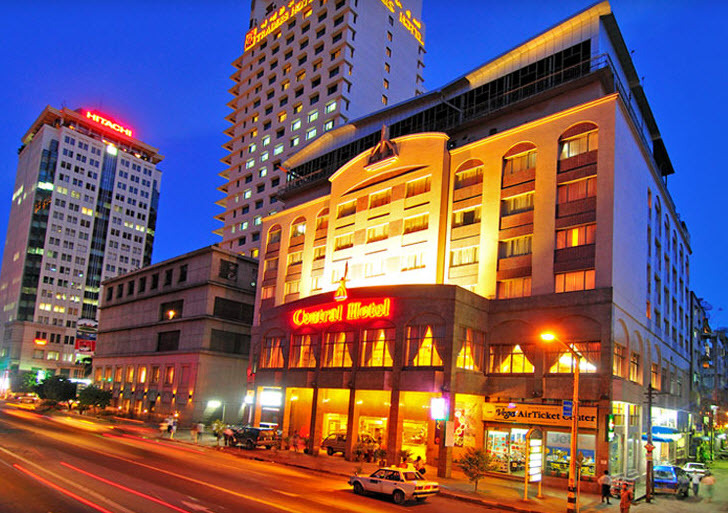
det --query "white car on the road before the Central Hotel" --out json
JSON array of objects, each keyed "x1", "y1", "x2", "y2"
[{"x1": 349, "y1": 467, "x2": 440, "y2": 504}]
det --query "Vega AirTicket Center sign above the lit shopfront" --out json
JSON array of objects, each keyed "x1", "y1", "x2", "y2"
[{"x1": 483, "y1": 403, "x2": 597, "y2": 429}]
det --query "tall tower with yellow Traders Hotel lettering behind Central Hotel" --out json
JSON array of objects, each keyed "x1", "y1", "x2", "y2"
[{"x1": 215, "y1": 0, "x2": 425, "y2": 258}]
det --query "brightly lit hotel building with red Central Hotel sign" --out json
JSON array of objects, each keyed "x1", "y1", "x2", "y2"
[{"x1": 251, "y1": 2, "x2": 692, "y2": 487}]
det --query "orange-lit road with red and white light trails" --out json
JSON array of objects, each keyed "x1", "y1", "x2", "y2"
[{"x1": 0, "y1": 404, "x2": 494, "y2": 513}]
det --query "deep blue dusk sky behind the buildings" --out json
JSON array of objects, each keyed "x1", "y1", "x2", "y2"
[{"x1": 0, "y1": 0, "x2": 728, "y2": 327}]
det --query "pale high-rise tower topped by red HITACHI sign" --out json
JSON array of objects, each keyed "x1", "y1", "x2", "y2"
[{"x1": 0, "y1": 106, "x2": 163, "y2": 386}]
